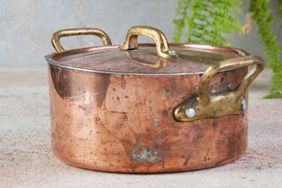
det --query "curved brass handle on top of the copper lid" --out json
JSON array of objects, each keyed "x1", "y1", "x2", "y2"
[{"x1": 120, "y1": 26, "x2": 177, "y2": 59}]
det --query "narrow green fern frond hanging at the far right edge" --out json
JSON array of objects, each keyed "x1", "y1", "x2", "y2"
[{"x1": 249, "y1": 0, "x2": 282, "y2": 98}]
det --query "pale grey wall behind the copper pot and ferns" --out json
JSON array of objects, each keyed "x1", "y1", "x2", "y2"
[{"x1": 0, "y1": 0, "x2": 281, "y2": 64}]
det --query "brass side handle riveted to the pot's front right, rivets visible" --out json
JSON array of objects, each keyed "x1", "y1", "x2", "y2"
[{"x1": 173, "y1": 56, "x2": 265, "y2": 121}]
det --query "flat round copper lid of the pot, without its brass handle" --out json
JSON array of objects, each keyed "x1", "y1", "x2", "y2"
[{"x1": 47, "y1": 44, "x2": 247, "y2": 75}]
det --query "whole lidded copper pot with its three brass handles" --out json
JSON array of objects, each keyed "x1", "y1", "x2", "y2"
[{"x1": 46, "y1": 26, "x2": 264, "y2": 173}]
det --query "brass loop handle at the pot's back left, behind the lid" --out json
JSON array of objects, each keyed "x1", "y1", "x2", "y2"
[{"x1": 51, "y1": 28, "x2": 112, "y2": 52}]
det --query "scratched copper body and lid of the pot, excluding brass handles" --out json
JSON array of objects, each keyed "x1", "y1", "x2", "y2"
[{"x1": 47, "y1": 44, "x2": 247, "y2": 173}]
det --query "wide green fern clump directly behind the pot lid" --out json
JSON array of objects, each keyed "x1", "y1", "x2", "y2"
[{"x1": 174, "y1": 0, "x2": 241, "y2": 45}]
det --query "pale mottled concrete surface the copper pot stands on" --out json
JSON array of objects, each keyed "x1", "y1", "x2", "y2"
[{"x1": 0, "y1": 65, "x2": 282, "y2": 188}]
